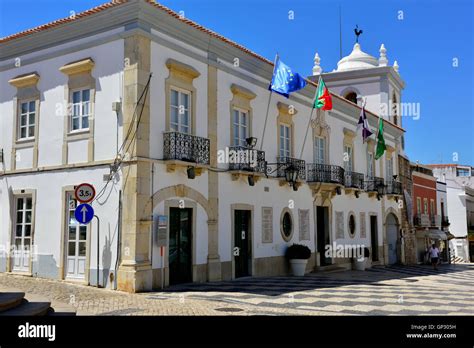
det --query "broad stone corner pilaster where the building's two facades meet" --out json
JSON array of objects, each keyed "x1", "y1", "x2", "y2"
[{"x1": 117, "y1": 34, "x2": 153, "y2": 292}]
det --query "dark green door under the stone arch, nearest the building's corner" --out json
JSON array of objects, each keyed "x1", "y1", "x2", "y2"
[{"x1": 168, "y1": 208, "x2": 193, "y2": 285}]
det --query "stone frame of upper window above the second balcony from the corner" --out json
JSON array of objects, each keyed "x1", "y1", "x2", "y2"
[{"x1": 229, "y1": 83, "x2": 257, "y2": 146}]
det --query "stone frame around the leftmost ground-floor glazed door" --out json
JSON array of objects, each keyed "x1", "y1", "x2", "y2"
[{"x1": 7, "y1": 189, "x2": 36, "y2": 275}]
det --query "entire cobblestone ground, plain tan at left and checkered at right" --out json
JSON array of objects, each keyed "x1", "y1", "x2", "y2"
[{"x1": 0, "y1": 264, "x2": 474, "y2": 315}]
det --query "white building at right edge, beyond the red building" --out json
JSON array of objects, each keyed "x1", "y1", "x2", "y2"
[{"x1": 428, "y1": 164, "x2": 474, "y2": 262}]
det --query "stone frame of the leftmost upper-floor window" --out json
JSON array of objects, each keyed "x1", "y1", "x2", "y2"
[{"x1": 8, "y1": 72, "x2": 41, "y2": 170}]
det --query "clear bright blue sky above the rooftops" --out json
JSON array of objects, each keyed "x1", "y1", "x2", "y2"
[{"x1": 0, "y1": 0, "x2": 474, "y2": 165}]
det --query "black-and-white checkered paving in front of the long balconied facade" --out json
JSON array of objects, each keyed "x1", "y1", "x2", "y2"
[{"x1": 155, "y1": 265, "x2": 474, "y2": 315}]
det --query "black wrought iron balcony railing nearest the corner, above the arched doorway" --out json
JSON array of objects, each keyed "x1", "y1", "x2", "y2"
[{"x1": 163, "y1": 132, "x2": 210, "y2": 164}]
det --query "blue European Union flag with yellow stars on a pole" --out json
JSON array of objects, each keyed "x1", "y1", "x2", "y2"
[{"x1": 268, "y1": 57, "x2": 306, "y2": 98}]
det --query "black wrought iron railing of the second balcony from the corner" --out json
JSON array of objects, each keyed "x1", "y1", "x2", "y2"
[{"x1": 229, "y1": 146, "x2": 266, "y2": 174}]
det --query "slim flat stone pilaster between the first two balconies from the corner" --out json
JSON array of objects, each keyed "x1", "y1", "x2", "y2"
[{"x1": 207, "y1": 56, "x2": 222, "y2": 281}]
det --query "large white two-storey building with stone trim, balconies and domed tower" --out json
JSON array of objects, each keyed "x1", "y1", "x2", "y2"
[{"x1": 0, "y1": 0, "x2": 404, "y2": 292}]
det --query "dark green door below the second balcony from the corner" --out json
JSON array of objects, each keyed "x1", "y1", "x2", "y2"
[{"x1": 234, "y1": 210, "x2": 252, "y2": 278}]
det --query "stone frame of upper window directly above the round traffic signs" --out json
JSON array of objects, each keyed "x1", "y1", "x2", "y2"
[{"x1": 59, "y1": 57, "x2": 97, "y2": 164}]
